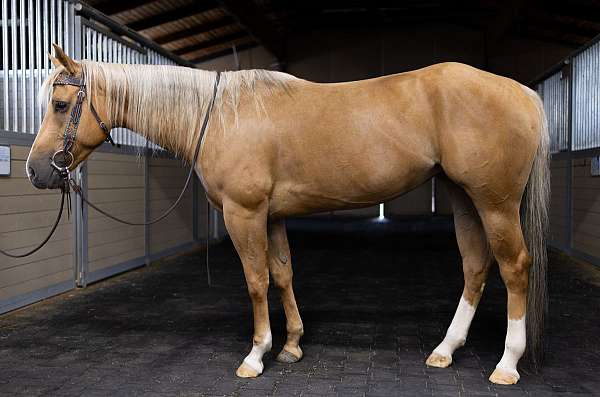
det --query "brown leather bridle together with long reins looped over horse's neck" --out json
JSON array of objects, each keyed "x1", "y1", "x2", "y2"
[{"x1": 0, "y1": 72, "x2": 221, "y2": 258}]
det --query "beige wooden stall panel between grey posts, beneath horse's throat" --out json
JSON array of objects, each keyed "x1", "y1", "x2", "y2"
[{"x1": 87, "y1": 152, "x2": 145, "y2": 272}]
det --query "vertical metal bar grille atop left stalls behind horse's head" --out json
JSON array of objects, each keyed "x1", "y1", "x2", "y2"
[{"x1": 0, "y1": 0, "x2": 188, "y2": 149}]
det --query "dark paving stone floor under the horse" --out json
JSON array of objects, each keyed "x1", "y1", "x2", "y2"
[{"x1": 0, "y1": 220, "x2": 600, "y2": 397}]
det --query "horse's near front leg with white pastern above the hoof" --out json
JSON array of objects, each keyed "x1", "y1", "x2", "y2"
[{"x1": 223, "y1": 202, "x2": 272, "y2": 378}]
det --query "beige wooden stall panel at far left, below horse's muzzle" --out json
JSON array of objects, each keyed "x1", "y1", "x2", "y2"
[{"x1": 0, "y1": 145, "x2": 74, "y2": 312}]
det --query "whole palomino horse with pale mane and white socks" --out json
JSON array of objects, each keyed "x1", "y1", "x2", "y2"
[{"x1": 27, "y1": 47, "x2": 549, "y2": 384}]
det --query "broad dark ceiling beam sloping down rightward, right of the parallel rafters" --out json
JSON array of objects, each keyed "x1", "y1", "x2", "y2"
[{"x1": 218, "y1": 0, "x2": 285, "y2": 61}]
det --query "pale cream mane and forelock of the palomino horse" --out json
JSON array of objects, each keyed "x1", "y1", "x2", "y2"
[{"x1": 40, "y1": 60, "x2": 296, "y2": 157}]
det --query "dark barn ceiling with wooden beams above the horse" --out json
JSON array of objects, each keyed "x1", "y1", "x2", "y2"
[{"x1": 86, "y1": 0, "x2": 600, "y2": 63}]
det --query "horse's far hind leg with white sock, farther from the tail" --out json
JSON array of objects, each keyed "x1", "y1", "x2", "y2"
[{"x1": 426, "y1": 183, "x2": 491, "y2": 368}]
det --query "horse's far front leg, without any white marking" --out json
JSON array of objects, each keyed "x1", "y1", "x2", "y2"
[{"x1": 268, "y1": 220, "x2": 304, "y2": 363}]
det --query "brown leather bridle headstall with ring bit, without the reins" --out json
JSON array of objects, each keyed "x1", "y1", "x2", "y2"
[{"x1": 50, "y1": 72, "x2": 119, "y2": 180}]
